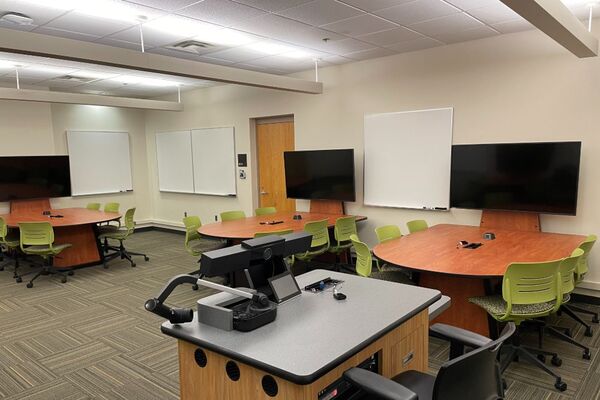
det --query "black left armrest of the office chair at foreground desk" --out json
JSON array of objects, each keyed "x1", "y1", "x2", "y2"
[{"x1": 344, "y1": 368, "x2": 419, "y2": 400}]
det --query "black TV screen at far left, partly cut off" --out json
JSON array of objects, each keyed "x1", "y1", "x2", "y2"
[{"x1": 0, "y1": 156, "x2": 71, "y2": 201}]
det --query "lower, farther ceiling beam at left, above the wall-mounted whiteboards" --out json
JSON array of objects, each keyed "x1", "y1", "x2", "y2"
[{"x1": 0, "y1": 88, "x2": 183, "y2": 111}]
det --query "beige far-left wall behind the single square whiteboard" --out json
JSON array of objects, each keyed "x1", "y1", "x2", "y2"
[{"x1": 0, "y1": 101, "x2": 152, "y2": 221}]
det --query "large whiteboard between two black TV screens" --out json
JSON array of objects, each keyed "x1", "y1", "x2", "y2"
[{"x1": 364, "y1": 108, "x2": 453, "y2": 209}]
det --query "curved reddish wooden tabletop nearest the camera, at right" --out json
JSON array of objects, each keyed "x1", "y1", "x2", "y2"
[{"x1": 373, "y1": 224, "x2": 585, "y2": 277}]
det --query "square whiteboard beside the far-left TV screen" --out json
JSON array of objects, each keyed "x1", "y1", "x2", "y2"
[{"x1": 67, "y1": 131, "x2": 133, "y2": 196}]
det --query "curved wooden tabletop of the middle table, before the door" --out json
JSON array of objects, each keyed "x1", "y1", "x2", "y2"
[{"x1": 198, "y1": 212, "x2": 367, "y2": 239}]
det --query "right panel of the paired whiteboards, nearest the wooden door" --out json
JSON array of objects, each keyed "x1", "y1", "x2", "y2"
[{"x1": 192, "y1": 127, "x2": 236, "y2": 196}]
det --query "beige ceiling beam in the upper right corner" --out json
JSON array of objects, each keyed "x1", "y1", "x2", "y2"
[{"x1": 502, "y1": 0, "x2": 598, "y2": 58}]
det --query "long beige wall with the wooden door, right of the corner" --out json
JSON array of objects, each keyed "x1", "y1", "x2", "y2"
[{"x1": 146, "y1": 31, "x2": 600, "y2": 289}]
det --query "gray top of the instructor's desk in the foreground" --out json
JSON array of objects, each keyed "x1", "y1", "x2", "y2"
[{"x1": 161, "y1": 270, "x2": 441, "y2": 384}]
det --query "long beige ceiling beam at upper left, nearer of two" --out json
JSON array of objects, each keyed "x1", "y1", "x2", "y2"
[{"x1": 0, "y1": 28, "x2": 323, "y2": 94}]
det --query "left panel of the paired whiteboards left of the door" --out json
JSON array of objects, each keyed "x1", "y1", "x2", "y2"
[{"x1": 156, "y1": 131, "x2": 194, "y2": 193}]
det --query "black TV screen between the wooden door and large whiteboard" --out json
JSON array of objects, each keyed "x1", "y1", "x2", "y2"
[{"x1": 284, "y1": 149, "x2": 356, "y2": 201}]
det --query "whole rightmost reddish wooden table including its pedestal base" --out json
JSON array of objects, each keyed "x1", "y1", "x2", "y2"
[{"x1": 373, "y1": 224, "x2": 585, "y2": 336}]
